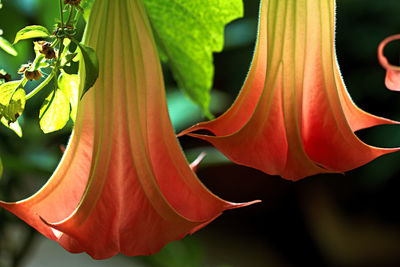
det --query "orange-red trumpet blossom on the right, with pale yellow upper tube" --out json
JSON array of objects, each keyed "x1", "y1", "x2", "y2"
[{"x1": 180, "y1": 0, "x2": 398, "y2": 180}]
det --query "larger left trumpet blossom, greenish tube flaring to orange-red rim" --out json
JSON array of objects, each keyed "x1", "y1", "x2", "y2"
[{"x1": 0, "y1": 0, "x2": 256, "y2": 259}]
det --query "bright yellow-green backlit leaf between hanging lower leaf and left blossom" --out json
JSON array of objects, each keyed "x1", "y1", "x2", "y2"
[{"x1": 58, "y1": 70, "x2": 79, "y2": 122}]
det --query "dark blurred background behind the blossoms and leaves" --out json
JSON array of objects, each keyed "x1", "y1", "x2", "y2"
[{"x1": 0, "y1": 0, "x2": 400, "y2": 267}]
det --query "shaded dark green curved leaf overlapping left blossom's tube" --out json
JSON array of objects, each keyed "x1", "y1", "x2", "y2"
[{"x1": 73, "y1": 40, "x2": 99, "y2": 99}]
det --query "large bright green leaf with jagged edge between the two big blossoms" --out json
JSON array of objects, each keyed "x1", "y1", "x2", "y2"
[{"x1": 144, "y1": 0, "x2": 243, "y2": 117}]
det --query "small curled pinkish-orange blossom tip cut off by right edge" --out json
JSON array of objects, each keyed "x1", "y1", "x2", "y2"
[{"x1": 378, "y1": 34, "x2": 400, "y2": 91}]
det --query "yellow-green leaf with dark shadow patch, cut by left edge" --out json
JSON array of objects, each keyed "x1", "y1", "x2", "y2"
[{"x1": 0, "y1": 81, "x2": 25, "y2": 123}]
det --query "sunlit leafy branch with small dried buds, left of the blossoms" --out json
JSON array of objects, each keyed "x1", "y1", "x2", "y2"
[{"x1": 0, "y1": 0, "x2": 99, "y2": 180}]
